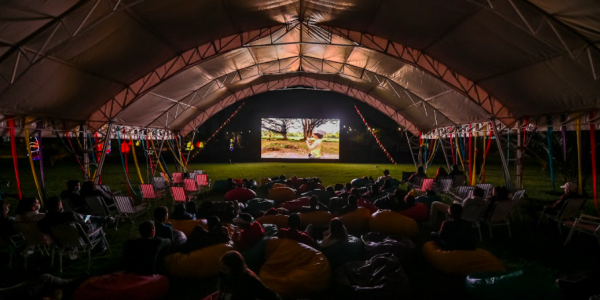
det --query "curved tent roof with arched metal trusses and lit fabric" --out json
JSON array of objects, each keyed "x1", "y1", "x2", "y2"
[{"x1": 0, "y1": 0, "x2": 600, "y2": 133}]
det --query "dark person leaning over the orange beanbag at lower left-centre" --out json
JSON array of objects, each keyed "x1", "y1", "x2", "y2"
[{"x1": 181, "y1": 216, "x2": 231, "y2": 253}]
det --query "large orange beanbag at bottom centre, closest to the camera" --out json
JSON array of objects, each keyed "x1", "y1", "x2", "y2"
[{"x1": 258, "y1": 239, "x2": 331, "y2": 297}]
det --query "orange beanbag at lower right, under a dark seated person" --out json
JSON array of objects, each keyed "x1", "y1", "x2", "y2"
[{"x1": 423, "y1": 241, "x2": 504, "y2": 275}]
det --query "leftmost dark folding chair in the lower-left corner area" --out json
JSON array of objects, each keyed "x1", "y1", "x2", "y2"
[{"x1": 14, "y1": 221, "x2": 54, "y2": 268}]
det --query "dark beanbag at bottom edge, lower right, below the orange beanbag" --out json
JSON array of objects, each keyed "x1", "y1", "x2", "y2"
[{"x1": 465, "y1": 270, "x2": 560, "y2": 300}]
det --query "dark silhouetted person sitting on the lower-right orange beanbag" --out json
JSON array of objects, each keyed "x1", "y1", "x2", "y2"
[{"x1": 431, "y1": 204, "x2": 475, "y2": 251}]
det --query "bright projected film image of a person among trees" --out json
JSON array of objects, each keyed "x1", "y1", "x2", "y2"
[{"x1": 260, "y1": 118, "x2": 340, "y2": 159}]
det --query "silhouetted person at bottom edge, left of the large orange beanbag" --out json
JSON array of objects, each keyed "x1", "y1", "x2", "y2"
[{"x1": 219, "y1": 251, "x2": 280, "y2": 300}]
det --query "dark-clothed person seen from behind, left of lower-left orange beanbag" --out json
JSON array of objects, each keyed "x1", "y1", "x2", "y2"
[{"x1": 123, "y1": 221, "x2": 171, "y2": 275}]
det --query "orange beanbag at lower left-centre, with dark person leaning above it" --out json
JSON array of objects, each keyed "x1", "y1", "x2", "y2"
[{"x1": 166, "y1": 242, "x2": 234, "y2": 278}]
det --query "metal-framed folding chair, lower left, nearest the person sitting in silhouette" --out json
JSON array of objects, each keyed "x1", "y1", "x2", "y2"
[{"x1": 50, "y1": 223, "x2": 110, "y2": 273}]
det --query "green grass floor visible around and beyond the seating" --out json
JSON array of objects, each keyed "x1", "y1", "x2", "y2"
[{"x1": 0, "y1": 161, "x2": 600, "y2": 299}]
